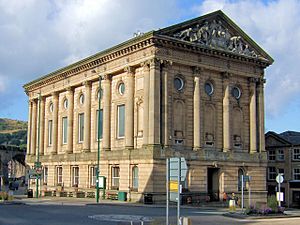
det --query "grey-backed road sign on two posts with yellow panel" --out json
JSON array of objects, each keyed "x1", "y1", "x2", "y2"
[{"x1": 166, "y1": 157, "x2": 188, "y2": 225}]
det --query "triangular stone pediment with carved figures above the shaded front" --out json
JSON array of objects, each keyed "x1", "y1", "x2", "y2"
[{"x1": 157, "y1": 11, "x2": 273, "y2": 64}]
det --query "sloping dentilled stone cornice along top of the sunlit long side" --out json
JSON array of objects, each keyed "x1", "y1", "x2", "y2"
[{"x1": 23, "y1": 31, "x2": 155, "y2": 93}]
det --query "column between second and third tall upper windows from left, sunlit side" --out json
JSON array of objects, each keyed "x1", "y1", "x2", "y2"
[{"x1": 66, "y1": 87, "x2": 74, "y2": 154}]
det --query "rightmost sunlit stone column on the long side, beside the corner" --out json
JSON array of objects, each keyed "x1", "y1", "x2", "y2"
[{"x1": 141, "y1": 61, "x2": 150, "y2": 145}]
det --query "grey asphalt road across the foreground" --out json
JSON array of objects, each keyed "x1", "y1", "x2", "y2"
[{"x1": 0, "y1": 204, "x2": 300, "y2": 225}]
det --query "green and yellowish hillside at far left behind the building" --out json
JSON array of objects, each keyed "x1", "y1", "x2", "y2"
[{"x1": 0, "y1": 118, "x2": 27, "y2": 148}]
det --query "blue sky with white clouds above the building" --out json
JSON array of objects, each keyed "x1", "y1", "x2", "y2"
[{"x1": 0, "y1": 0, "x2": 300, "y2": 133}]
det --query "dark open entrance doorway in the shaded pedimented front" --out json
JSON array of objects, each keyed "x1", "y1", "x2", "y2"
[{"x1": 207, "y1": 168, "x2": 220, "y2": 201}]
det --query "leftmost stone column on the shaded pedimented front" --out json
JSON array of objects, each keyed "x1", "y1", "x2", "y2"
[{"x1": 161, "y1": 60, "x2": 172, "y2": 146}]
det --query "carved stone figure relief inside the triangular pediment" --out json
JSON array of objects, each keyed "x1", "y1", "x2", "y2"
[{"x1": 173, "y1": 20, "x2": 258, "y2": 58}]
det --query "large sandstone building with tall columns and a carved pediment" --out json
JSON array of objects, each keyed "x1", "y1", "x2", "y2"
[{"x1": 24, "y1": 11, "x2": 273, "y2": 204}]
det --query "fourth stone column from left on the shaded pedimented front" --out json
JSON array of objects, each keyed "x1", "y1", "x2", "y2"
[{"x1": 249, "y1": 78, "x2": 257, "y2": 153}]
